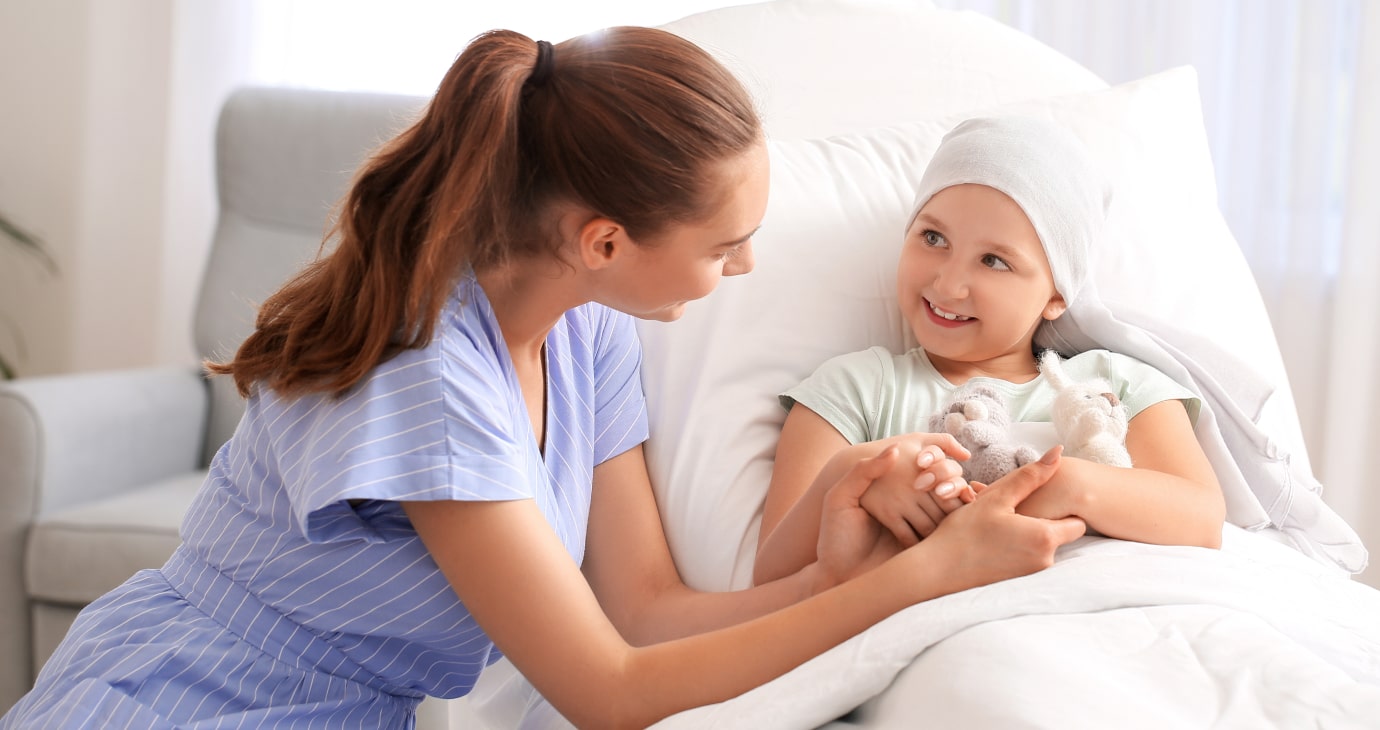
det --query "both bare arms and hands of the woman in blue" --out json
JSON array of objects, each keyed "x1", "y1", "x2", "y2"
[{"x1": 404, "y1": 447, "x2": 1082, "y2": 727}]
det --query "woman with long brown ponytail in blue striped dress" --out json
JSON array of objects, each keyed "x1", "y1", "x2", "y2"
[{"x1": 0, "y1": 28, "x2": 1083, "y2": 729}]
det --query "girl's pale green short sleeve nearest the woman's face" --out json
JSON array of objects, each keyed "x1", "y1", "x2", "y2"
[{"x1": 780, "y1": 348, "x2": 891, "y2": 443}]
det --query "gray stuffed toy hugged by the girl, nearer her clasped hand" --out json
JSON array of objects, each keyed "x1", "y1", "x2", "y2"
[{"x1": 930, "y1": 385, "x2": 1039, "y2": 484}]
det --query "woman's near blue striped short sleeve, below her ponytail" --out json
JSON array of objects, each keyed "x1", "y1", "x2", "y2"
[{"x1": 275, "y1": 299, "x2": 540, "y2": 541}]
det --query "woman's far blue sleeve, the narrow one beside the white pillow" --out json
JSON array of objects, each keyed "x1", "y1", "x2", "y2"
[{"x1": 592, "y1": 308, "x2": 649, "y2": 465}]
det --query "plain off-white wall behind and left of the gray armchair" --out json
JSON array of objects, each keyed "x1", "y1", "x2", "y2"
[{"x1": 0, "y1": 0, "x2": 248, "y2": 374}]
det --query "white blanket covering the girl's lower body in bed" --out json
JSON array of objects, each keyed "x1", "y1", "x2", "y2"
[{"x1": 656, "y1": 526, "x2": 1380, "y2": 730}]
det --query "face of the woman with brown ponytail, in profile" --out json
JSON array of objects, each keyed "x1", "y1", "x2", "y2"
[{"x1": 603, "y1": 145, "x2": 770, "y2": 322}]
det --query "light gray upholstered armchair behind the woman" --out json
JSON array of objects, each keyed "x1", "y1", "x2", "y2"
[{"x1": 0, "y1": 83, "x2": 425, "y2": 711}]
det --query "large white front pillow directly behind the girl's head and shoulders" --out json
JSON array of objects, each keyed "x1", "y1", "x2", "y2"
[{"x1": 639, "y1": 68, "x2": 1304, "y2": 589}]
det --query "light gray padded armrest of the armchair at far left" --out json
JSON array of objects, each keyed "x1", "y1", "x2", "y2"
[{"x1": 0, "y1": 367, "x2": 208, "y2": 513}]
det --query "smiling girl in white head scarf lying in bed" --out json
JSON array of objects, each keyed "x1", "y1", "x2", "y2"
[{"x1": 755, "y1": 117, "x2": 1225, "y2": 582}]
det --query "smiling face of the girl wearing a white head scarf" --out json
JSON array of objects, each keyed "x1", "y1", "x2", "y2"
[{"x1": 897, "y1": 185, "x2": 1064, "y2": 379}]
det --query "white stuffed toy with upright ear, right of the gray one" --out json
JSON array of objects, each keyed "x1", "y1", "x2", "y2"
[{"x1": 1041, "y1": 351, "x2": 1130, "y2": 466}]
